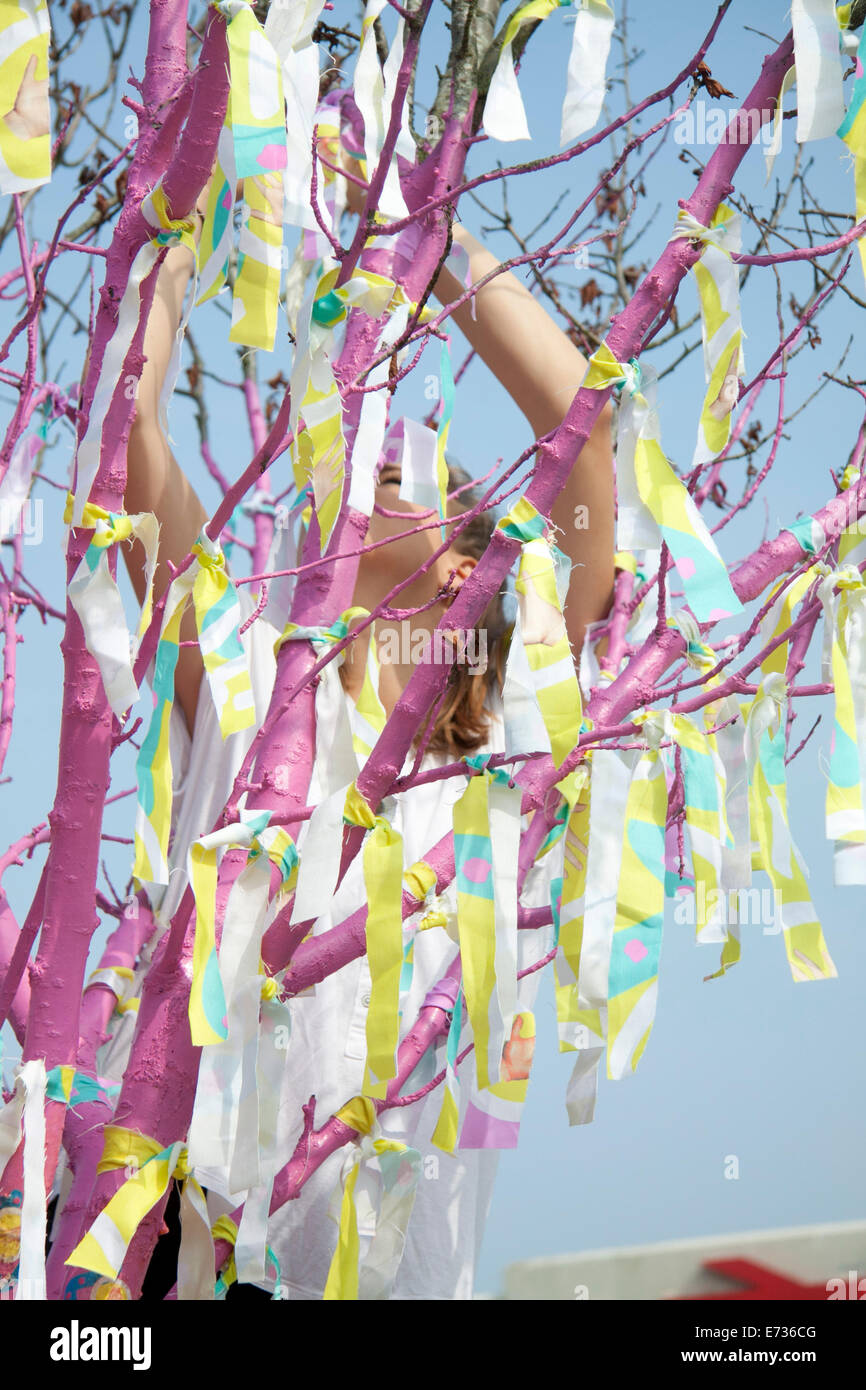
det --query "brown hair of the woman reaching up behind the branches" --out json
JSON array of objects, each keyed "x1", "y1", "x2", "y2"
[{"x1": 416, "y1": 459, "x2": 509, "y2": 758}]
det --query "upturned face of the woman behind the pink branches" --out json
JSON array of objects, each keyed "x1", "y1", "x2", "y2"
[{"x1": 356, "y1": 463, "x2": 475, "y2": 607}]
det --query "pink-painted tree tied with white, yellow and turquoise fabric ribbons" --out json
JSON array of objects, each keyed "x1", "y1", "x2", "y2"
[{"x1": 0, "y1": 0, "x2": 866, "y2": 1298}]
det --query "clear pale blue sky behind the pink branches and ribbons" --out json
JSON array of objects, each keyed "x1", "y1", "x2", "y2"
[{"x1": 0, "y1": 0, "x2": 866, "y2": 1291}]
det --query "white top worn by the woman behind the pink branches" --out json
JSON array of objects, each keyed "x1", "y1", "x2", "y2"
[{"x1": 100, "y1": 591, "x2": 562, "y2": 1300}]
